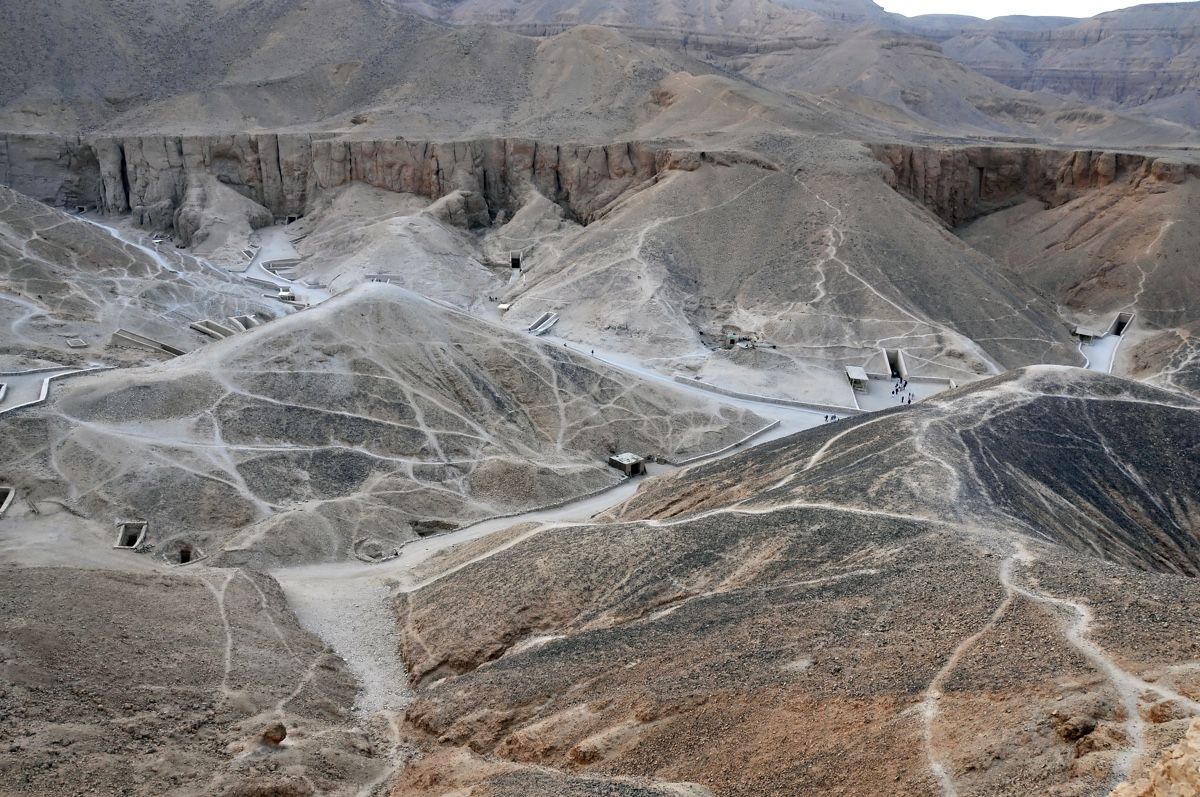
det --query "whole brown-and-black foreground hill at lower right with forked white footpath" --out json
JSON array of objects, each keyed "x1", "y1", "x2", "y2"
[{"x1": 392, "y1": 370, "x2": 1200, "y2": 796}]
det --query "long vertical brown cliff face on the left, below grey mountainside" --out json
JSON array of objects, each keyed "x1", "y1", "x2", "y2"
[{"x1": 0, "y1": 133, "x2": 753, "y2": 229}]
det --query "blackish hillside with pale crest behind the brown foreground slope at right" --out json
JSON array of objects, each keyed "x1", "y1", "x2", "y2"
[{"x1": 614, "y1": 366, "x2": 1200, "y2": 576}]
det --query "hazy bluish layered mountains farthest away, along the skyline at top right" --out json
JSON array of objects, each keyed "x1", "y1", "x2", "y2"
[{"x1": 402, "y1": 0, "x2": 1200, "y2": 124}]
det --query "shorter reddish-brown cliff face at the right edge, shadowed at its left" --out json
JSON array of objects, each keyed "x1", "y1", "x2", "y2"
[{"x1": 871, "y1": 144, "x2": 1200, "y2": 227}]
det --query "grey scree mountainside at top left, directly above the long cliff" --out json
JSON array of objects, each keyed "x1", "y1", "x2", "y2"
[{"x1": 0, "y1": 0, "x2": 712, "y2": 140}]
